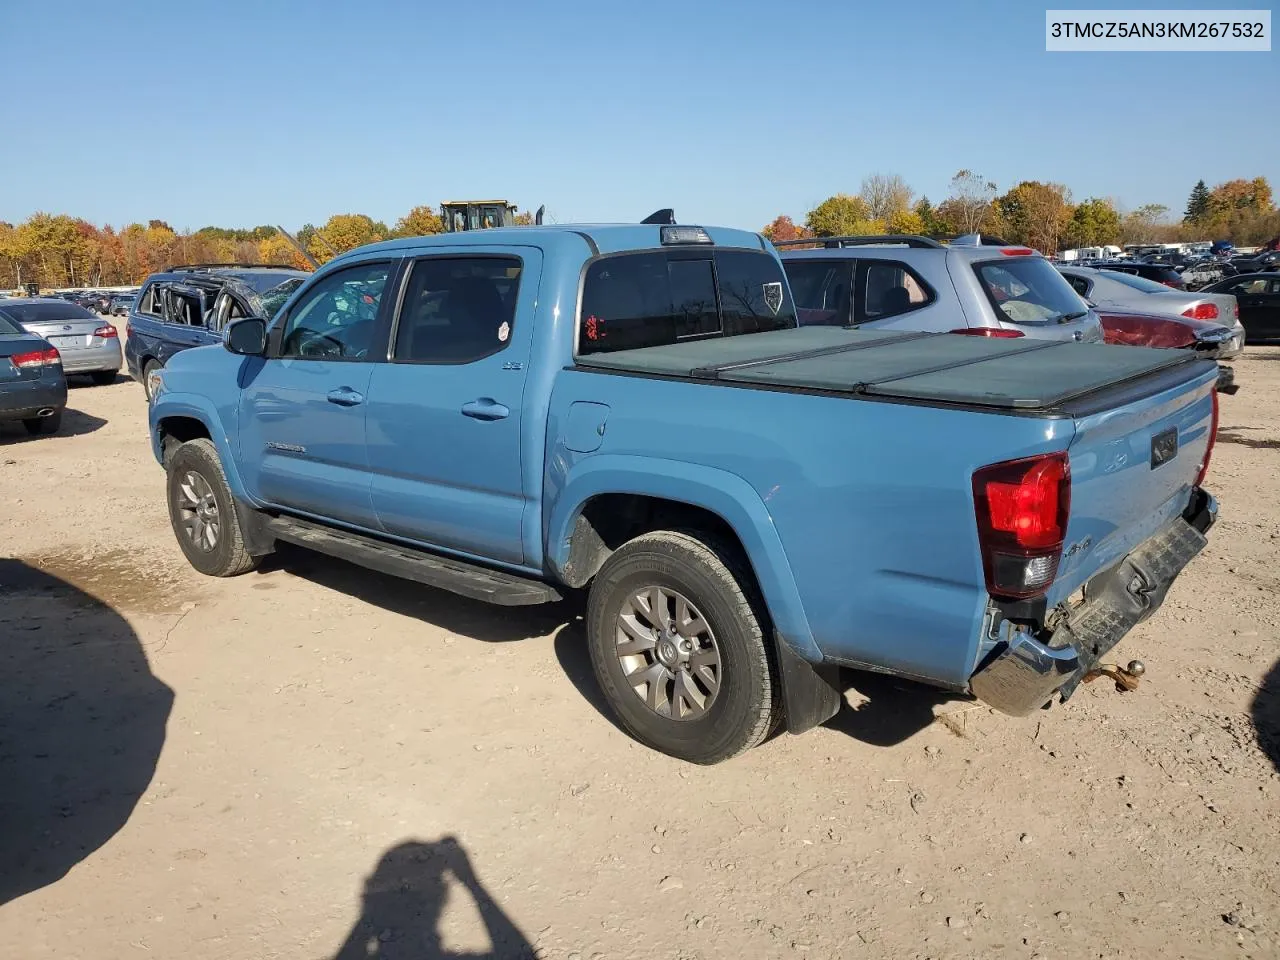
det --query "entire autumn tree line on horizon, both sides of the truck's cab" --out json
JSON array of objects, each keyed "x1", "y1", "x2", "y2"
[{"x1": 0, "y1": 170, "x2": 1280, "y2": 289}]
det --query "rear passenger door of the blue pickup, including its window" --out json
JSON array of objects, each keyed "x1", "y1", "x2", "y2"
[{"x1": 367, "y1": 247, "x2": 541, "y2": 564}]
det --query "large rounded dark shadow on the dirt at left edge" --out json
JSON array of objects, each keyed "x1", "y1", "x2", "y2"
[{"x1": 0, "y1": 558, "x2": 173, "y2": 904}]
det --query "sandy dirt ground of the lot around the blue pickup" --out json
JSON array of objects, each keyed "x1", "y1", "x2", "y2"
[{"x1": 0, "y1": 348, "x2": 1280, "y2": 960}]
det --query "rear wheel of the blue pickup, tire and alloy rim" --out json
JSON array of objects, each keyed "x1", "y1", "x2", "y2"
[{"x1": 586, "y1": 530, "x2": 778, "y2": 764}]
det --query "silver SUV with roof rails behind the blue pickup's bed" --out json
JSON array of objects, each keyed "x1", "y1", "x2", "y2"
[{"x1": 776, "y1": 234, "x2": 1102, "y2": 342}]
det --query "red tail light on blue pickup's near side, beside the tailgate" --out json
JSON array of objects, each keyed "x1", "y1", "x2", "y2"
[{"x1": 973, "y1": 452, "x2": 1071, "y2": 599}]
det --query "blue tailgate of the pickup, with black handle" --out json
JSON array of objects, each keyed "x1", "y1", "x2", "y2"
[{"x1": 1048, "y1": 364, "x2": 1217, "y2": 604}]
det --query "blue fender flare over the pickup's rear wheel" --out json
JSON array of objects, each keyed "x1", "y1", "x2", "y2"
[{"x1": 545, "y1": 454, "x2": 822, "y2": 663}]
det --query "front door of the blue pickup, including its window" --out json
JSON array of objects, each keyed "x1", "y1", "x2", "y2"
[{"x1": 239, "y1": 261, "x2": 394, "y2": 530}]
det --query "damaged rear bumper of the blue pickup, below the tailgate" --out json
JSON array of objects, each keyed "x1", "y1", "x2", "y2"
[{"x1": 969, "y1": 489, "x2": 1217, "y2": 717}]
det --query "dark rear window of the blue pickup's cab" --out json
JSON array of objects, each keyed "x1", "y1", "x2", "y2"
[{"x1": 577, "y1": 250, "x2": 796, "y2": 355}]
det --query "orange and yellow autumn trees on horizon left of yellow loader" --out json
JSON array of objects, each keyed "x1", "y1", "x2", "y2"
[{"x1": 0, "y1": 206, "x2": 534, "y2": 289}]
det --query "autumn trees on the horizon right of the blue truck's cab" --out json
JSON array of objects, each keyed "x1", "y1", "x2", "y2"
[{"x1": 763, "y1": 170, "x2": 1280, "y2": 255}]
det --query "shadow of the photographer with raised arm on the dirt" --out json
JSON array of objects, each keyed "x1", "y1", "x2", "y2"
[{"x1": 333, "y1": 837, "x2": 534, "y2": 960}]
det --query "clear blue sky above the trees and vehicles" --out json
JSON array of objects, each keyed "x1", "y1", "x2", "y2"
[{"x1": 0, "y1": 0, "x2": 1280, "y2": 229}]
